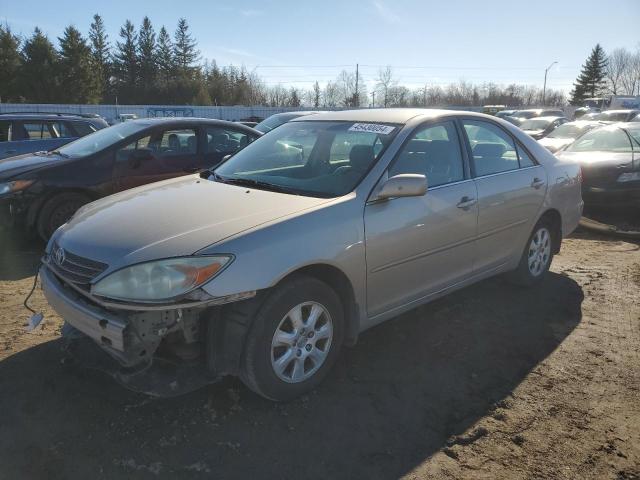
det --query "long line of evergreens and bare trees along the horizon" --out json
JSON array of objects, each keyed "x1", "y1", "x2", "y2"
[{"x1": 0, "y1": 14, "x2": 640, "y2": 108}]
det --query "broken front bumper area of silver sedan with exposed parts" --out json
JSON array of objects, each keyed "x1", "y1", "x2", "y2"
[{"x1": 40, "y1": 259, "x2": 255, "y2": 396}]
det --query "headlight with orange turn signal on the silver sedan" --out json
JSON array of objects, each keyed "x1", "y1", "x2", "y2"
[{"x1": 91, "y1": 255, "x2": 232, "y2": 302}]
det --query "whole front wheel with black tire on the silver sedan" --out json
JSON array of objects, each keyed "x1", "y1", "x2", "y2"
[{"x1": 240, "y1": 276, "x2": 344, "y2": 401}]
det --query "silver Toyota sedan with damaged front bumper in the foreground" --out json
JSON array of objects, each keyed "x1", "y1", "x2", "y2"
[{"x1": 41, "y1": 109, "x2": 582, "y2": 400}]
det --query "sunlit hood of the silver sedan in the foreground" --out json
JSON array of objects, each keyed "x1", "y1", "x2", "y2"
[{"x1": 48, "y1": 175, "x2": 331, "y2": 271}]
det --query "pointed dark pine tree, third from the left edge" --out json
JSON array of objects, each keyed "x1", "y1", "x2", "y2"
[{"x1": 58, "y1": 25, "x2": 100, "y2": 103}]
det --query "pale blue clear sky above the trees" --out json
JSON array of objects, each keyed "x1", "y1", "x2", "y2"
[{"x1": 0, "y1": 0, "x2": 640, "y2": 93}]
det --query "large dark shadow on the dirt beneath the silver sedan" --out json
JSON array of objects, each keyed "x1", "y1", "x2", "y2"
[{"x1": 0, "y1": 273, "x2": 583, "y2": 479}]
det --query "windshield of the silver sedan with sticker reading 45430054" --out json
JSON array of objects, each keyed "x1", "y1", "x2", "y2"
[{"x1": 211, "y1": 121, "x2": 400, "y2": 198}]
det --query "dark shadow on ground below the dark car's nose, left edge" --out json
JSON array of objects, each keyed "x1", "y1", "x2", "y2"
[{"x1": 0, "y1": 230, "x2": 45, "y2": 281}]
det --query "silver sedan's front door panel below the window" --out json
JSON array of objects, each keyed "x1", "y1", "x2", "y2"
[{"x1": 364, "y1": 180, "x2": 478, "y2": 316}]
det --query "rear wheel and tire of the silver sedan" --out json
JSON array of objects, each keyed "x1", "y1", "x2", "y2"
[{"x1": 508, "y1": 218, "x2": 557, "y2": 287}]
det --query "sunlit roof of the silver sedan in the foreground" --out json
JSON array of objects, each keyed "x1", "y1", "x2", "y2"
[{"x1": 291, "y1": 108, "x2": 470, "y2": 124}]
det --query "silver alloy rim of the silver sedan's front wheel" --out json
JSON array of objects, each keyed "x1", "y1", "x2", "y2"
[{"x1": 271, "y1": 302, "x2": 333, "y2": 383}]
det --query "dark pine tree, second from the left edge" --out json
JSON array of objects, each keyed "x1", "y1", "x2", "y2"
[{"x1": 19, "y1": 27, "x2": 58, "y2": 103}]
